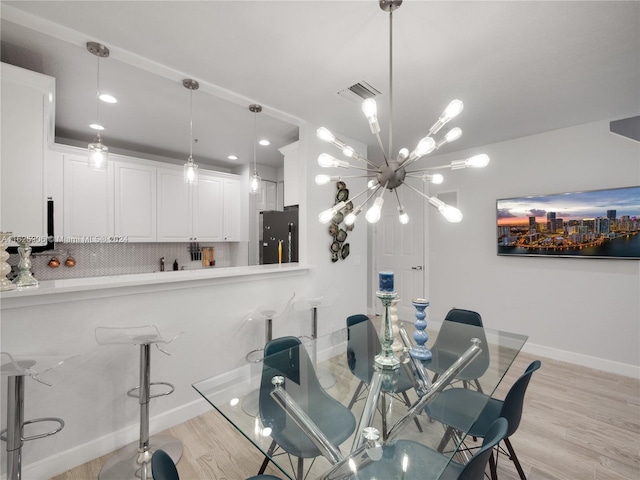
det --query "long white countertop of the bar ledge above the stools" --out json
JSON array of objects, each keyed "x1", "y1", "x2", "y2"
[{"x1": 0, "y1": 263, "x2": 311, "y2": 310}]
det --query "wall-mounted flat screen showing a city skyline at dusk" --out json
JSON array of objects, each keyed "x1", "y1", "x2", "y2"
[{"x1": 496, "y1": 186, "x2": 640, "y2": 260}]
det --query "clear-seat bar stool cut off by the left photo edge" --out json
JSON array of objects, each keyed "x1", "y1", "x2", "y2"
[{"x1": 0, "y1": 352, "x2": 64, "y2": 480}]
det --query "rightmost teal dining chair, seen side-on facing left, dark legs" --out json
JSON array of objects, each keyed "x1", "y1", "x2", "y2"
[{"x1": 425, "y1": 360, "x2": 542, "y2": 480}]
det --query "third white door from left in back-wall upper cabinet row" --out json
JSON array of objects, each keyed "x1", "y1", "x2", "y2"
[{"x1": 157, "y1": 168, "x2": 193, "y2": 242}]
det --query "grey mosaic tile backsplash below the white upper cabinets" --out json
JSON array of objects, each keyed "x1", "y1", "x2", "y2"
[{"x1": 7, "y1": 243, "x2": 238, "y2": 280}]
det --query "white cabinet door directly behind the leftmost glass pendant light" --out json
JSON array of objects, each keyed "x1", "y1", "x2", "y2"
[{"x1": 63, "y1": 155, "x2": 114, "y2": 238}]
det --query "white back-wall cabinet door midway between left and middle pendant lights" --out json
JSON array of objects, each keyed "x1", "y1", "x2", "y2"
[{"x1": 114, "y1": 161, "x2": 157, "y2": 242}]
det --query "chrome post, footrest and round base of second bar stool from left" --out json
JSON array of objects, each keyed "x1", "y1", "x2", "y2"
[{"x1": 98, "y1": 343, "x2": 182, "y2": 480}]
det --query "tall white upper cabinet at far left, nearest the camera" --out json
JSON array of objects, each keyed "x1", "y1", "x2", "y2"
[{"x1": 0, "y1": 63, "x2": 55, "y2": 245}]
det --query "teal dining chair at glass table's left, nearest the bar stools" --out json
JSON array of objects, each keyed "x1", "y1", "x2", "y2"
[{"x1": 258, "y1": 336, "x2": 356, "y2": 480}]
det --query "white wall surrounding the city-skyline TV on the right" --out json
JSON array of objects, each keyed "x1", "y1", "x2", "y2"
[{"x1": 428, "y1": 121, "x2": 640, "y2": 376}]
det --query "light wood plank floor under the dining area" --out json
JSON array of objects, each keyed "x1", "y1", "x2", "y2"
[{"x1": 53, "y1": 353, "x2": 640, "y2": 480}]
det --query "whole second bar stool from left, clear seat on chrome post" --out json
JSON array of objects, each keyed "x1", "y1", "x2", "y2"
[{"x1": 96, "y1": 325, "x2": 182, "y2": 480}]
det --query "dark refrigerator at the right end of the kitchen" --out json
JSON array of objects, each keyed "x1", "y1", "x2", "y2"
[{"x1": 260, "y1": 205, "x2": 298, "y2": 264}]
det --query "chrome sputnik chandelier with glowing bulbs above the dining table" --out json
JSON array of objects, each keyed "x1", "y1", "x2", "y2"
[{"x1": 315, "y1": 0, "x2": 489, "y2": 225}]
